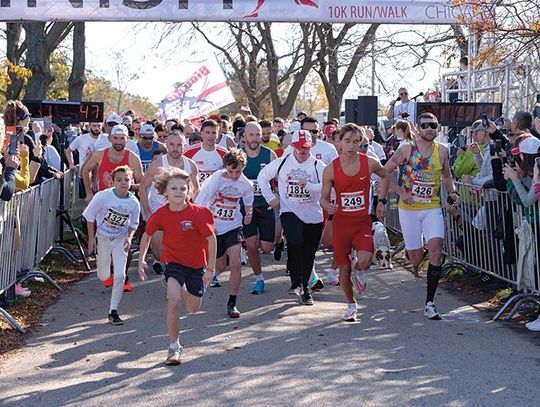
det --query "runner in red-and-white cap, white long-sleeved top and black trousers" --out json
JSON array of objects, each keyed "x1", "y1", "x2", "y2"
[{"x1": 257, "y1": 130, "x2": 324, "y2": 305}]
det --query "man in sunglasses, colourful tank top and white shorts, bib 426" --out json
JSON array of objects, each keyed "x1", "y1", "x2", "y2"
[{"x1": 377, "y1": 113, "x2": 460, "y2": 320}]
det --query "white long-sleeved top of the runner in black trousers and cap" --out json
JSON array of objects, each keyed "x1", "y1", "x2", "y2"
[{"x1": 257, "y1": 154, "x2": 324, "y2": 223}]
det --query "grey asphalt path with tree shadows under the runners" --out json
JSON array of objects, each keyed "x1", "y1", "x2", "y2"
[{"x1": 0, "y1": 254, "x2": 540, "y2": 407}]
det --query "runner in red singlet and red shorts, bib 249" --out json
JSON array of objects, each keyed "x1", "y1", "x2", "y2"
[{"x1": 321, "y1": 123, "x2": 387, "y2": 321}]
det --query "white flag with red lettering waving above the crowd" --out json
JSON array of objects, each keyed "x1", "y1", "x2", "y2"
[{"x1": 159, "y1": 58, "x2": 235, "y2": 121}]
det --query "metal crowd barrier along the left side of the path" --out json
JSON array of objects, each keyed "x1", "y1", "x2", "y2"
[{"x1": 0, "y1": 171, "x2": 85, "y2": 332}]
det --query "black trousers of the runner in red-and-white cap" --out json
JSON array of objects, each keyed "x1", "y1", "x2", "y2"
[{"x1": 280, "y1": 212, "x2": 323, "y2": 291}]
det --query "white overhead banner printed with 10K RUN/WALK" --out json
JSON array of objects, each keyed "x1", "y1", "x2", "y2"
[{"x1": 0, "y1": 0, "x2": 463, "y2": 24}]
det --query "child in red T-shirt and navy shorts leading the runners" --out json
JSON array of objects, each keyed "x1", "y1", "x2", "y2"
[{"x1": 139, "y1": 167, "x2": 217, "y2": 365}]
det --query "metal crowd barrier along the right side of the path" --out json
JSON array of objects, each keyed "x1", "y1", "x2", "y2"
[{"x1": 386, "y1": 182, "x2": 540, "y2": 320}]
